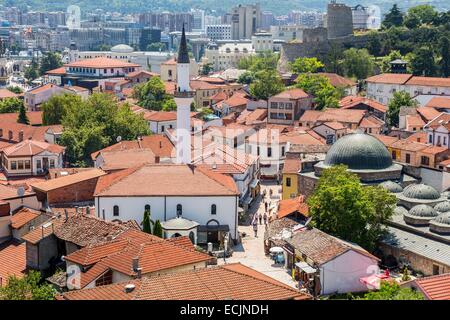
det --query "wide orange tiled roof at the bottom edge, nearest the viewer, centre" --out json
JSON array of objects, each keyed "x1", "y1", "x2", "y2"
[{"x1": 58, "y1": 264, "x2": 312, "y2": 300}]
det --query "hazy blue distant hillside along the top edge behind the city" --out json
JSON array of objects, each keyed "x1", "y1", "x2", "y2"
[{"x1": 0, "y1": 0, "x2": 450, "y2": 15}]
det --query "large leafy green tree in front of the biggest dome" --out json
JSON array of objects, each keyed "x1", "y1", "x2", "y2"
[{"x1": 308, "y1": 165, "x2": 396, "y2": 251}]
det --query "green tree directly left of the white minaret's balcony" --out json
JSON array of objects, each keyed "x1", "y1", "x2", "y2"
[{"x1": 133, "y1": 77, "x2": 177, "y2": 111}]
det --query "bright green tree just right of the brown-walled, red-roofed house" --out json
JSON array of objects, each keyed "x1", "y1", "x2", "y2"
[{"x1": 295, "y1": 73, "x2": 341, "y2": 110}]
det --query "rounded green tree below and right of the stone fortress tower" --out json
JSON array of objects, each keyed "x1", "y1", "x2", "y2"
[{"x1": 343, "y1": 48, "x2": 375, "y2": 80}]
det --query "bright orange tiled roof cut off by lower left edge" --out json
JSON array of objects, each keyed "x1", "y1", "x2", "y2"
[{"x1": 0, "y1": 242, "x2": 26, "y2": 286}]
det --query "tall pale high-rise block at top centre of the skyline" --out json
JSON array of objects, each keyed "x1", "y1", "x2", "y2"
[{"x1": 230, "y1": 4, "x2": 261, "y2": 40}]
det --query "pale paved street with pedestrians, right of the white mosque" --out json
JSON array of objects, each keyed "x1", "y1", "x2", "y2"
[{"x1": 218, "y1": 182, "x2": 295, "y2": 287}]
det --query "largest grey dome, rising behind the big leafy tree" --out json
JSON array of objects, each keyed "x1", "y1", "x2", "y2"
[{"x1": 324, "y1": 133, "x2": 392, "y2": 170}]
